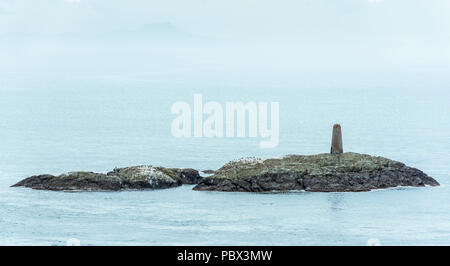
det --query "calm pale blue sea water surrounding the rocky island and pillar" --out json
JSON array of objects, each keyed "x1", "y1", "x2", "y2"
[{"x1": 0, "y1": 44, "x2": 450, "y2": 245}]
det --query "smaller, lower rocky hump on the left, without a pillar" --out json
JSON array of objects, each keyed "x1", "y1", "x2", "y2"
[{"x1": 13, "y1": 165, "x2": 183, "y2": 191}]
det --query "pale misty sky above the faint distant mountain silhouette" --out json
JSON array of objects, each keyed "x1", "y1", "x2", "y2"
[{"x1": 0, "y1": 0, "x2": 450, "y2": 42}]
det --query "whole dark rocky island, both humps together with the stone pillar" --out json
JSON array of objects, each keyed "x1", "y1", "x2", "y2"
[{"x1": 13, "y1": 124, "x2": 439, "y2": 192}]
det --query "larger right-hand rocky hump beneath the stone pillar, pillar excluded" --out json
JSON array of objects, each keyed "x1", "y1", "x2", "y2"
[{"x1": 194, "y1": 152, "x2": 439, "y2": 192}]
